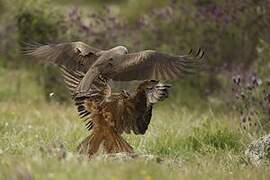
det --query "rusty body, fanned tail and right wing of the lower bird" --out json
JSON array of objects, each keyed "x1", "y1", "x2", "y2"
[{"x1": 75, "y1": 81, "x2": 170, "y2": 156}]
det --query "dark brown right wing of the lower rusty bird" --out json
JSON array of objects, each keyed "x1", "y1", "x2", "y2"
[{"x1": 111, "y1": 82, "x2": 170, "y2": 134}]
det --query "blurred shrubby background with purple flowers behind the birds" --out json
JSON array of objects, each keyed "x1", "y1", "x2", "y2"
[{"x1": 0, "y1": 0, "x2": 270, "y2": 134}]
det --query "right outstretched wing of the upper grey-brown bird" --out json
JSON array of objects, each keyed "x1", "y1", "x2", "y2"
[{"x1": 111, "y1": 49, "x2": 204, "y2": 81}]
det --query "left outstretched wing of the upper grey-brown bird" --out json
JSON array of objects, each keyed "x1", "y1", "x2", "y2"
[{"x1": 25, "y1": 41, "x2": 102, "y2": 73}]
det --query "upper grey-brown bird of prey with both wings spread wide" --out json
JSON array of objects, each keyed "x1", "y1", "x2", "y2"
[{"x1": 27, "y1": 42, "x2": 204, "y2": 96}]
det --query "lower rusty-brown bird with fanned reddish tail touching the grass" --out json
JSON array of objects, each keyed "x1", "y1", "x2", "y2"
[{"x1": 60, "y1": 66, "x2": 170, "y2": 157}]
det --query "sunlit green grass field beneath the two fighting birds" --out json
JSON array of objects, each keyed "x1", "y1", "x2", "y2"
[{"x1": 0, "y1": 65, "x2": 270, "y2": 180}]
